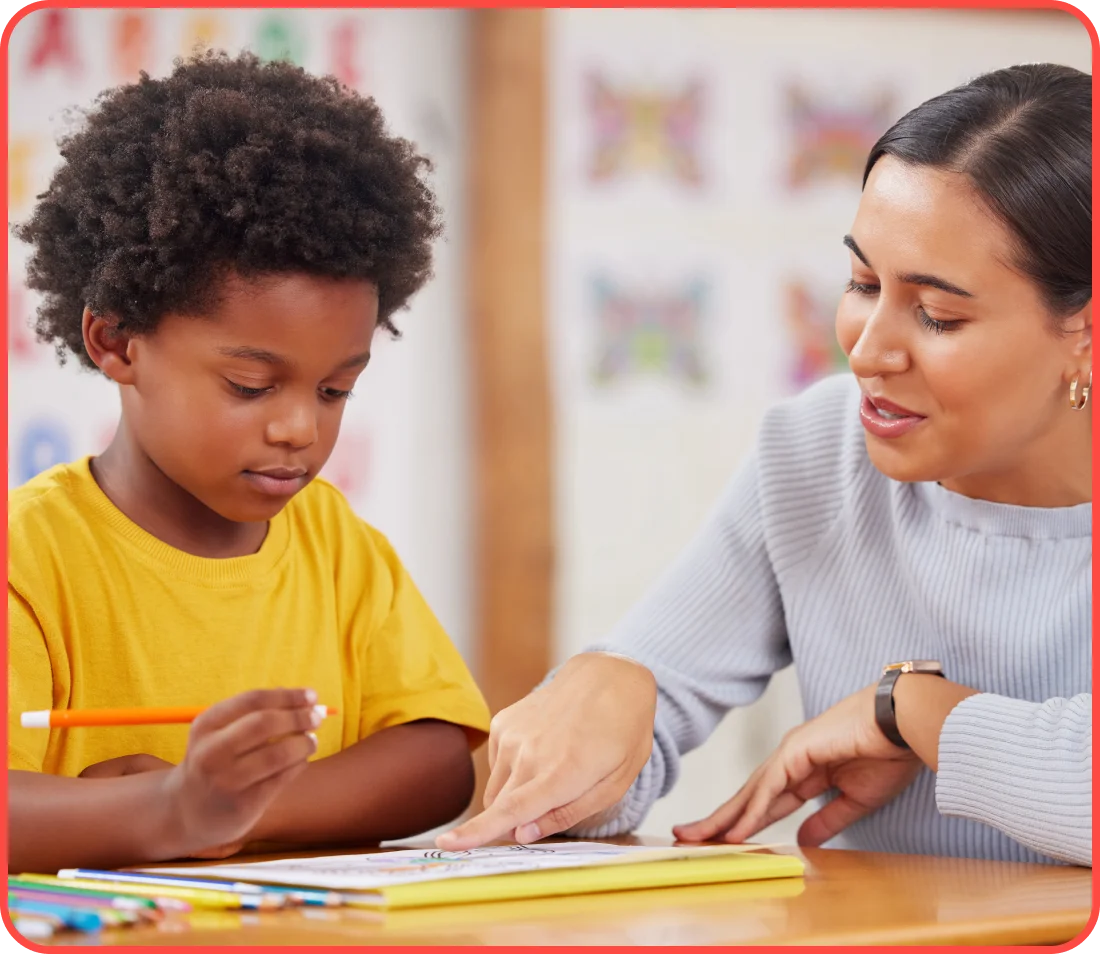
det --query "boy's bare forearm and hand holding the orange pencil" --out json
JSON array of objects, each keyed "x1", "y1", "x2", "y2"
[{"x1": 8, "y1": 689, "x2": 317, "y2": 874}]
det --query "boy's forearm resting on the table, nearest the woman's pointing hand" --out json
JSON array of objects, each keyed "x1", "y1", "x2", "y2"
[{"x1": 250, "y1": 721, "x2": 474, "y2": 845}]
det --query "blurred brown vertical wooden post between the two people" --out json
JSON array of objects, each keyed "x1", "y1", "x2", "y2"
[{"x1": 470, "y1": 9, "x2": 553, "y2": 726}]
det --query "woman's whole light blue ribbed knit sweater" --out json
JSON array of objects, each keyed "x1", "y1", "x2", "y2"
[{"x1": 572, "y1": 374, "x2": 1092, "y2": 865}]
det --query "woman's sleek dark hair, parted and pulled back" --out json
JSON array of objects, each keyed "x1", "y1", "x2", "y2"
[{"x1": 864, "y1": 64, "x2": 1092, "y2": 318}]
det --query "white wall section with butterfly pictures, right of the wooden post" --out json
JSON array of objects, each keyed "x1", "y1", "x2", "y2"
[{"x1": 548, "y1": 9, "x2": 1091, "y2": 840}]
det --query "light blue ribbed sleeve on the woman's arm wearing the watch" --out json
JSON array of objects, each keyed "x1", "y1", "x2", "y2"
[{"x1": 936, "y1": 693, "x2": 1092, "y2": 866}]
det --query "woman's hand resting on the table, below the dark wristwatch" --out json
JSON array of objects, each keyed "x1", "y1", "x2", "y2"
[{"x1": 673, "y1": 686, "x2": 922, "y2": 846}]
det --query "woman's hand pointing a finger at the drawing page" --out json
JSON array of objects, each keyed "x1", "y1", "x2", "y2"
[{"x1": 437, "y1": 653, "x2": 657, "y2": 851}]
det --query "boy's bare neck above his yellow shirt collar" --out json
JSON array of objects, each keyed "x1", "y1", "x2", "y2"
[{"x1": 91, "y1": 423, "x2": 267, "y2": 559}]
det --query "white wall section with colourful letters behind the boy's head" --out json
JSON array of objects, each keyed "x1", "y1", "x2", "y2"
[{"x1": 8, "y1": 9, "x2": 474, "y2": 658}]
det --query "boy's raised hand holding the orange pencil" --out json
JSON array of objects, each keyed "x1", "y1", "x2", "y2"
[{"x1": 164, "y1": 689, "x2": 320, "y2": 857}]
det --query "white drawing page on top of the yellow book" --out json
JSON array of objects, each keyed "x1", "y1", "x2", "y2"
[{"x1": 139, "y1": 842, "x2": 750, "y2": 891}]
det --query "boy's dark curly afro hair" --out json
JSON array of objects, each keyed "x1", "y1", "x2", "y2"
[{"x1": 14, "y1": 47, "x2": 441, "y2": 368}]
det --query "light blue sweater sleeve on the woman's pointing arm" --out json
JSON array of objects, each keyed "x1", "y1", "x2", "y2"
[{"x1": 570, "y1": 375, "x2": 862, "y2": 837}]
